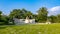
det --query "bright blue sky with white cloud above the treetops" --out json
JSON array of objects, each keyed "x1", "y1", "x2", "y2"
[{"x1": 0, "y1": 0, "x2": 60, "y2": 15}]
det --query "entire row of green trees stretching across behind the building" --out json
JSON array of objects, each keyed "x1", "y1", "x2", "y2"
[{"x1": 0, "y1": 7, "x2": 60, "y2": 25}]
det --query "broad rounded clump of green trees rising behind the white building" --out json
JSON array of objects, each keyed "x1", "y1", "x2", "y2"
[{"x1": 10, "y1": 9, "x2": 32, "y2": 19}]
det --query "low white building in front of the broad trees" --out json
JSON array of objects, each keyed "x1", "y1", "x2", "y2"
[{"x1": 13, "y1": 17, "x2": 35, "y2": 25}]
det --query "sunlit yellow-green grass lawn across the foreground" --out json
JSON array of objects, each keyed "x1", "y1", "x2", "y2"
[{"x1": 0, "y1": 24, "x2": 60, "y2": 34}]
